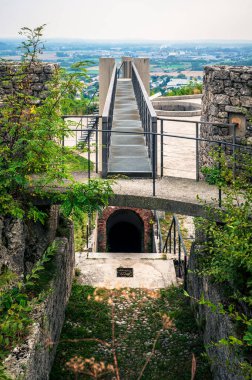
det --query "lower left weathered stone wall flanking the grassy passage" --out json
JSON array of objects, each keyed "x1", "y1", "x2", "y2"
[{"x1": 4, "y1": 230, "x2": 74, "y2": 380}]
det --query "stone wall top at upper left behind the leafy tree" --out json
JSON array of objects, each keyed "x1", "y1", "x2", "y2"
[{"x1": 0, "y1": 62, "x2": 58, "y2": 103}]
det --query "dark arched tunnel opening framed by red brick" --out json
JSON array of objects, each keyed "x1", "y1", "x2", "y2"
[{"x1": 106, "y1": 210, "x2": 144, "y2": 253}]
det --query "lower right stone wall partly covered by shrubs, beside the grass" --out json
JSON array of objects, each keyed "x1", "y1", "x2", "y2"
[{"x1": 188, "y1": 245, "x2": 244, "y2": 380}]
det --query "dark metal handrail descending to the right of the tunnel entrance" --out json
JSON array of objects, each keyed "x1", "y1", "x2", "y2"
[{"x1": 163, "y1": 215, "x2": 188, "y2": 289}]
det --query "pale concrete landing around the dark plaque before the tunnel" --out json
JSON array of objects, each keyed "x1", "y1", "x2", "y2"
[{"x1": 76, "y1": 253, "x2": 177, "y2": 289}]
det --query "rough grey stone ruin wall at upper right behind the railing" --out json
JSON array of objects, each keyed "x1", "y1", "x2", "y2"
[{"x1": 200, "y1": 66, "x2": 252, "y2": 167}]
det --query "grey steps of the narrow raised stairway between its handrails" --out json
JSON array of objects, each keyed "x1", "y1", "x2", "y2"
[{"x1": 108, "y1": 79, "x2": 152, "y2": 177}]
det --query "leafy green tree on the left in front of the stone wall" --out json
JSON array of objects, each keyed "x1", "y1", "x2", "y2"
[{"x1": 0, "y1": 25, "x2": 111, "y2": 221}]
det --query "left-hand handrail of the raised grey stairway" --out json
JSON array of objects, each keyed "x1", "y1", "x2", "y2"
[{"x1": 102, "y1": 64, "x2": 117, "y2": 177}]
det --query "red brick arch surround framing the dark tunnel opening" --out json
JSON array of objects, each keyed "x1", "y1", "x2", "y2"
[{"x1": 98, "y1": 206, "x2": 154, "y2": 252}]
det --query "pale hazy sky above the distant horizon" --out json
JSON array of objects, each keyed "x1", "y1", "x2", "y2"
[{"x1": 0, "y1": 0, "x2": 252, "y2": 41}]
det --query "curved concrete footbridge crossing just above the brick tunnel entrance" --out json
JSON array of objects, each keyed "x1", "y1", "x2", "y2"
[{"x1": 71, "y1": 173, "x2": 218, "y2": 216}]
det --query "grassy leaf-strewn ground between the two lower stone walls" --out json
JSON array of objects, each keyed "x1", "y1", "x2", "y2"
[{"x1": 50, "y1": 283, "x2": 212, "y2": 380}]
